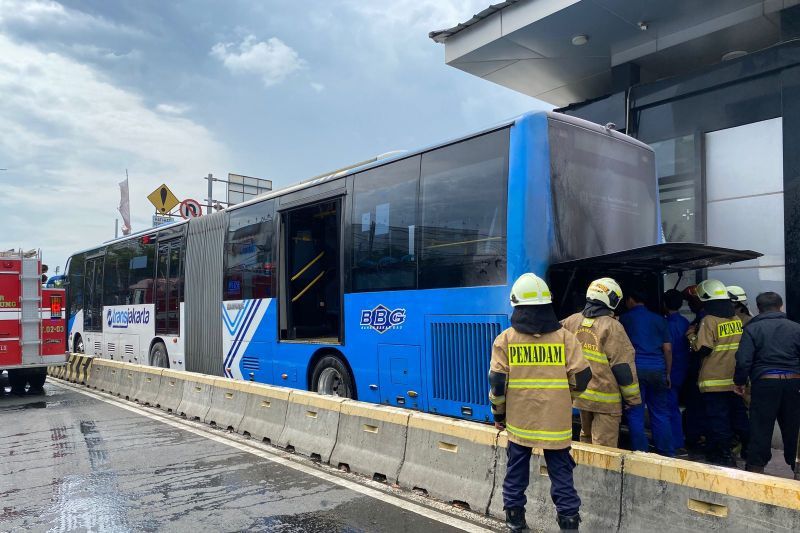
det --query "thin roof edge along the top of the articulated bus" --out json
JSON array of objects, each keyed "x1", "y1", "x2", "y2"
[{"x1": 72, "y1": 111, "x2": 652, "y2": 255}]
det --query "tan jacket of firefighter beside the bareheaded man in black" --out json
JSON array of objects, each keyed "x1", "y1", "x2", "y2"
[{"x1": 692, "y1": 315, "x2": 742, "y2": 392}]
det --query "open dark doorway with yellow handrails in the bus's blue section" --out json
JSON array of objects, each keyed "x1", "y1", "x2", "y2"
[{"x1": 280, "y1": 198, "x2": 342, "y2": 343}]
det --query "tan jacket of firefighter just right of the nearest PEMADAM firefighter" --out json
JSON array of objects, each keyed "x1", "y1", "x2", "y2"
[{"x1": 562, "y1": 313, "x2": 642, "y2": 414}]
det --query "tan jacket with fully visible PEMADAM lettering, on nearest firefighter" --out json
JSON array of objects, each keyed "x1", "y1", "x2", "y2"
[{"x1": 490, "y1": 328, "x2": 589, "y2": 450}]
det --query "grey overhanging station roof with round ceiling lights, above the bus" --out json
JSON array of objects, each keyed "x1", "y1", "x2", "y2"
[{"x1": 429, "y1": 0, "x2": 800, "y2": 106}]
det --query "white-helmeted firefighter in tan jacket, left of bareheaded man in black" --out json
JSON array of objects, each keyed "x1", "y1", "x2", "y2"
[{"x1": 690, "y1": 279, "x2": 749, "y2": 466}]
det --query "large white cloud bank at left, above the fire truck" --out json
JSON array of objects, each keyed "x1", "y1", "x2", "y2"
[{"x1": 0, "y1": 34, "x2": 231, "y2": 267}]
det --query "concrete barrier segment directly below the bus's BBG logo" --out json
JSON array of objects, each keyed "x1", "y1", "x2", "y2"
[{"x1": 330, "y1": 401, "x2": 411, "y2": 483}]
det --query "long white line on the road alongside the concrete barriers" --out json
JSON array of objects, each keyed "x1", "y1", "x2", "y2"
[{"x1": 53, "y1": 380, "x2": 492, "y2": 533}]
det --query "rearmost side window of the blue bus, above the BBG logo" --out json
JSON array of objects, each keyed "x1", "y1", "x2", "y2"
[{"x1": 419, "y1": 129, "x2": 509, "y2": 289}]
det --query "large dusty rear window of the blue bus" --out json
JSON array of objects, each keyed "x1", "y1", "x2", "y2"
[{"x1": 549, "y1": 118, "x2": 658, "y2": 261}]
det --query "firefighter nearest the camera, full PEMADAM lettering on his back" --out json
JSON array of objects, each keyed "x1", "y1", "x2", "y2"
[{"x1": 489, "y1": 273, "x2": 592, "y2": 531}]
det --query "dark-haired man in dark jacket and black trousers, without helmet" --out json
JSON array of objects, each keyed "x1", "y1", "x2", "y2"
[{"x1": 733, "y1": 292, "x2": 800, "y2": 472}]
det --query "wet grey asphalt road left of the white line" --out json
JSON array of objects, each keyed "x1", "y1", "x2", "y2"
[{"x1": 0, "y1": 384, "x2": 490, "y2": 532}]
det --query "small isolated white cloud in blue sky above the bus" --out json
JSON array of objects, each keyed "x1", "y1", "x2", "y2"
[{"x1": 211, "y1": 35, "x2": 306, "y2": 87}]
